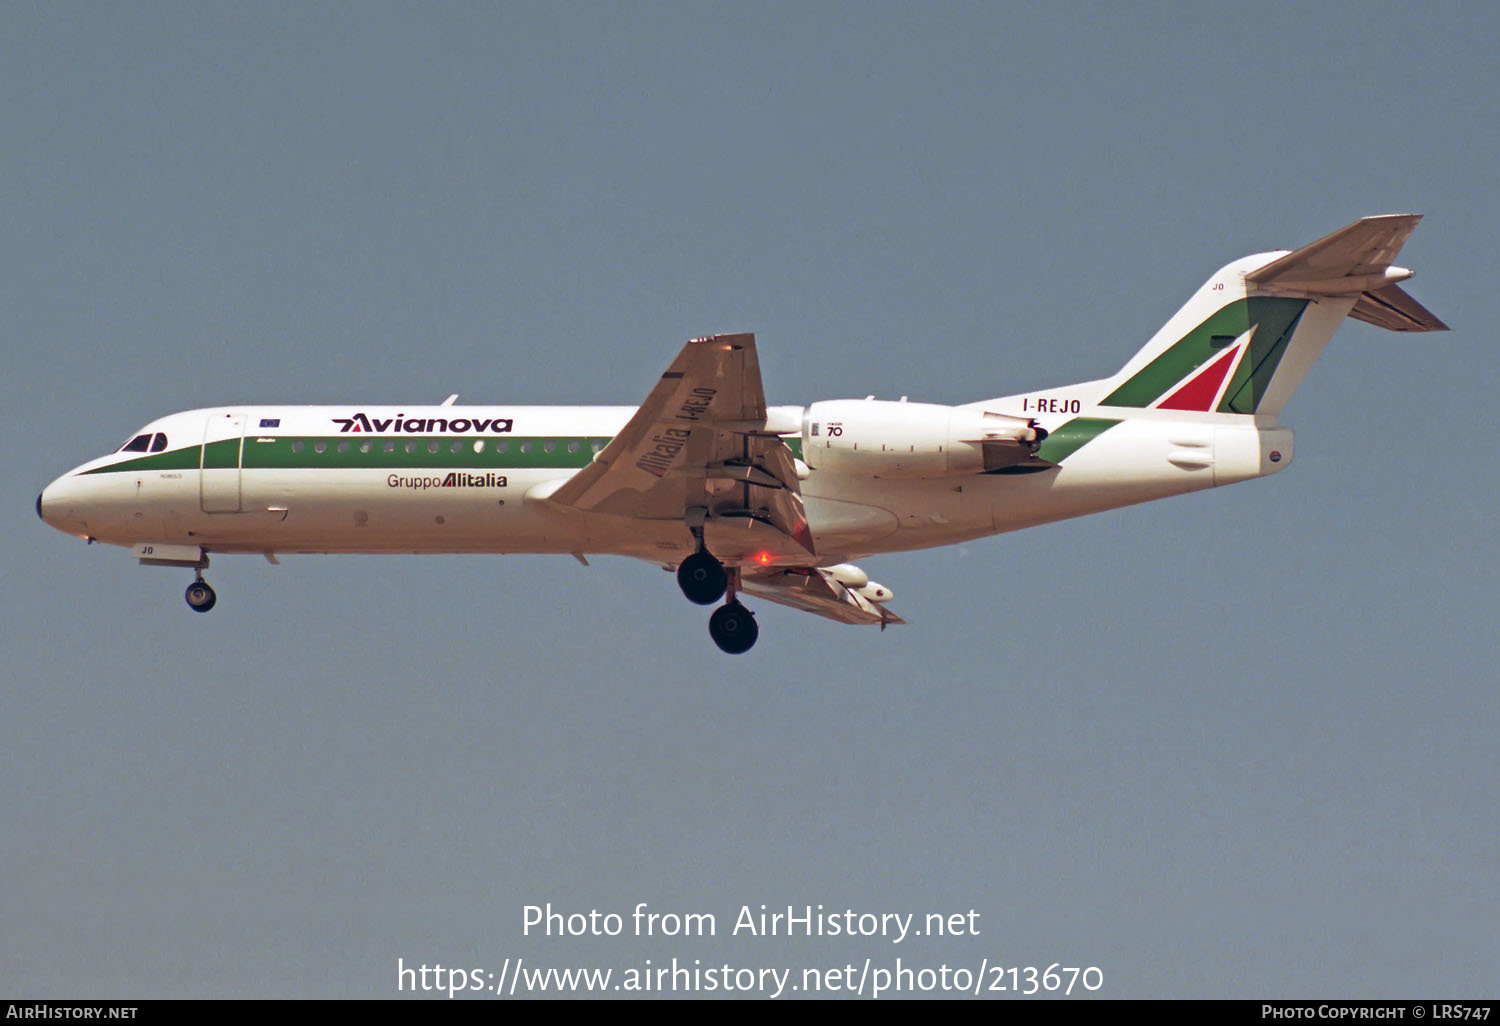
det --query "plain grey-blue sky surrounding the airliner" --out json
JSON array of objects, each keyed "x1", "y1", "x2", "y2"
[{"x1": 0, "y1": 3, "x2": 1500, "y2": 998}]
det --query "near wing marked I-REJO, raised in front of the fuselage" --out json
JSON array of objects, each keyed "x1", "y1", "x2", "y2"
[{"x1": 549, "y1": 335, "x2": 813, "y2": 558}]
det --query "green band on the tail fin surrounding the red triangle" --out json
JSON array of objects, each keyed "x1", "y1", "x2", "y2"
[{"x1": 1100, "y1": 296, "x2": 1308, "y2": 413}]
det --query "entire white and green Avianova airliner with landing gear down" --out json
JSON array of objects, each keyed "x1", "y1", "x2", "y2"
[{"x1": 36, "y1": 215, "x2": 1446, "y2": 653}]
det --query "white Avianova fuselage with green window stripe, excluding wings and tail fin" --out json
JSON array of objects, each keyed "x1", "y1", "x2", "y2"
[{"x1": 38, "y1": 393, "x2": 1292, "y2": 566}]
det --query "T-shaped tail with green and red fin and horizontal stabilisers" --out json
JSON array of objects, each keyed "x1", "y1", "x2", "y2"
[{"x1": 1097, "y1": 215, "x2": 1448, "y2": 423}]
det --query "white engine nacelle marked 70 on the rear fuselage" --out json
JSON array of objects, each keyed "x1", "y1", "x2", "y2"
[{"x1": 803, "y1": 399, "x2": 1047, "y2": 477}]
